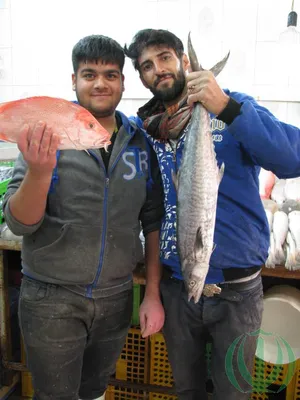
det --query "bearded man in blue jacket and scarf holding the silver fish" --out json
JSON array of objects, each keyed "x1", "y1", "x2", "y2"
[{"x1": 125, "y1": 29, "x2": 300, "y2": 400}]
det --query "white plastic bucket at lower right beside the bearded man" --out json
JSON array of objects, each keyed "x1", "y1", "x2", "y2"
[{"x1": 256, "y1": 285, "x2": 300, "y2": 364}]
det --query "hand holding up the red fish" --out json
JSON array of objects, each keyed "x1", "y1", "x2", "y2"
[{"x1": 17, "y1": 121, "x2": 60, "y2": 177}]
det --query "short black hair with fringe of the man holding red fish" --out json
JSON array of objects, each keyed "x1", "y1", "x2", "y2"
[{"x1": 72, "y1": 35, "x2": 125, "y2": 74}]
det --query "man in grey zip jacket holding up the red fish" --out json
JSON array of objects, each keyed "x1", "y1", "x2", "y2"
[{"x1": 4, "y1": 35, "x2": 164, "y2": 400}]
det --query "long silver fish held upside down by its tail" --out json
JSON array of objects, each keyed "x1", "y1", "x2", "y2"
[{"x1": 174, "y1": 35, "x2": 229, "y2": 303}]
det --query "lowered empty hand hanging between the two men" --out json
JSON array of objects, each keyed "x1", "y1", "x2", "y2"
[{"x1": 140, "y1": 294, "x2": 165, "y2": 338}]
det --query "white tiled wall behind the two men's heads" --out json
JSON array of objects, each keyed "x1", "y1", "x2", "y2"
[{"x1": 0, "y1": 0, "x2": 300, "y2": 125}]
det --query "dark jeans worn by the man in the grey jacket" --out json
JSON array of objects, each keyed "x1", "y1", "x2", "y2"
[{"x1": 19, "y1": 278, "x2": 132, "y2": 400}]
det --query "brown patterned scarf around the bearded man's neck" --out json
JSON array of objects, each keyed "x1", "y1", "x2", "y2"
[{"x1": 138, "y1": 96, "x2": 192, "y2": 142}]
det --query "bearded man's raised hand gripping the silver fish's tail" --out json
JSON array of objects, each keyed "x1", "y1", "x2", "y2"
[{"x1": 187, "y1": 71, "x2": 229, "y2": 115}]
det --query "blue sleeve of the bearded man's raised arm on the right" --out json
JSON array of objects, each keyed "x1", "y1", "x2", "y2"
[{"x1": 228, "y1": 93, "x2": 300, "y2": 178}]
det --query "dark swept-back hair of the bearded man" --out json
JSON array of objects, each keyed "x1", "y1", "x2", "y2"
[{"x1": 124, "y1": 29, "x2": 184, "y2": 71}]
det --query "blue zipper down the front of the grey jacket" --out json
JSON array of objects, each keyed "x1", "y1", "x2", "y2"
[{"x1": 87, "y1": 136, "x2": 132, "y2": 298}]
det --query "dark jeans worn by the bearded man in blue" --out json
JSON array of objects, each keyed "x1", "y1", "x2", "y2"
[{"x1": 161, "y1": 276, "x2": 263, "y2": 400}]
